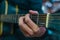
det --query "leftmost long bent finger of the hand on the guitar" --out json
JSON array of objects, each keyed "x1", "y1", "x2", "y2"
[{"x1": 19, "y1": 17, "x2": 33, "y2": 35}]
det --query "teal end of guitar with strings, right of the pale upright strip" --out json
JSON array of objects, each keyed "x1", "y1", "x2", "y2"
[{"x1": 48, "y1": 13, "x2": 60, "y2": 33}]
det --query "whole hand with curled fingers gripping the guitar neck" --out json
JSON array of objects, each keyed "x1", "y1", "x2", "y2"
[{"x1": 19, "y1": 10, "x2": 46, "y2": 37}]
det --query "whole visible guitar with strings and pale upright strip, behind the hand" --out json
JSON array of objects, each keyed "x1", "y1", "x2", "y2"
[{"x1": 0, "y1": 13, "x2": 60, "y2": 35}]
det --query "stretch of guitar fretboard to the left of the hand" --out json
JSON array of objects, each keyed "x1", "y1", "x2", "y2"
[{"x1": 0, "y1": 14, "x2": 23, "y2": 23}]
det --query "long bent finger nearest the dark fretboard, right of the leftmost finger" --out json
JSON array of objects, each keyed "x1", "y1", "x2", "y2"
[{"x1": 25, "y1": 14, "x2": 39, "y2": 33}]
